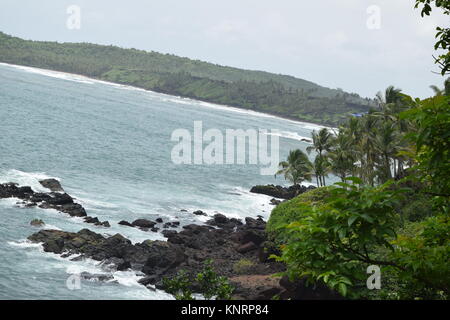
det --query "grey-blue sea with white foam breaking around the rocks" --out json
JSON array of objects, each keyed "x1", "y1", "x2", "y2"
[{"x1": 0, "y1": 64, "x2": 333, "y2": 299}]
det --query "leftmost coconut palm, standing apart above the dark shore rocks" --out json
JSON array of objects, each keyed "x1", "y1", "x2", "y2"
[{"x1": 275, "y1": 149, "x2": 313, "y2": 185}]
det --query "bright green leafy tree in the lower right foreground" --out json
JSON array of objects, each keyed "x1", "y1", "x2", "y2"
[{"x1": 274, "y1": 178, "x2": 450, "y2": 299}]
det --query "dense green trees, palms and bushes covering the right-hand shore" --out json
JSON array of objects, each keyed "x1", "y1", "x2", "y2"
[{"x1": 267, "y1": 79, "x2": 450, "y2": 299}]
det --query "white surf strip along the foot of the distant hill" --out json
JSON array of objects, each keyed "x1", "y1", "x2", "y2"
[{"x1": 0, "y1": 62, "x2": 337, "y2": 130}]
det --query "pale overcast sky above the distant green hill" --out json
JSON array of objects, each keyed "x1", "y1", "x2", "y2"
[{"x1": 0, "y1": 0, "x2": 448, "y2": 97}]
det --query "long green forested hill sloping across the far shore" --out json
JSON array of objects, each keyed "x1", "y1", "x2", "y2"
[{"x1": 0, "y1": 32, "x2": 372, "y2": 126}]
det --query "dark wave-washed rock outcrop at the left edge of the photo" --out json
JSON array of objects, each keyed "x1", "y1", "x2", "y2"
[{"x1": 0, "y1": 182, "x2": 110, "y2": 227}]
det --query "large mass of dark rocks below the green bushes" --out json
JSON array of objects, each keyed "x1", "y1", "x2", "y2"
[{"x1": 24, "y1": 199, "x2": 328, "y2": 299}]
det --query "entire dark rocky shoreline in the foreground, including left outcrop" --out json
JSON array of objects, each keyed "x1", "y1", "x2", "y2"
[{"x1": 0, "y1": 182, "x2": 338, "y2": 300}]
